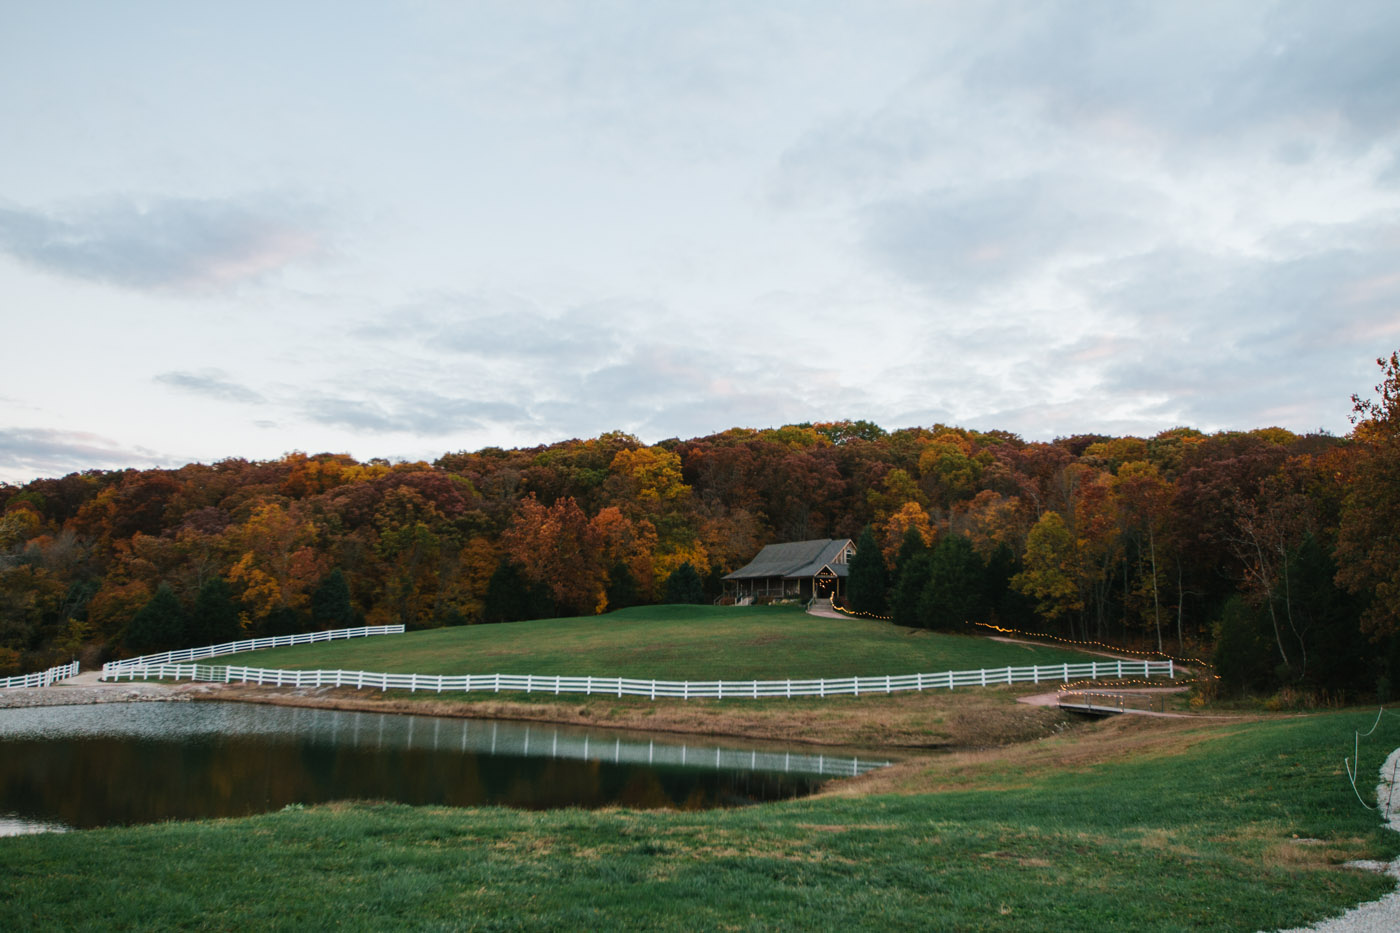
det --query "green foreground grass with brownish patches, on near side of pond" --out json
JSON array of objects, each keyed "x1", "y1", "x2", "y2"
[{"x1": 0, "y1": 713, "x2": 1400, "y2": 932}]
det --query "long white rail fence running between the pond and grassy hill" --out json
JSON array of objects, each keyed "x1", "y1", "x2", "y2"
[{"x1": 102, "y1": 652, "x2": 1176, "y2": 699}]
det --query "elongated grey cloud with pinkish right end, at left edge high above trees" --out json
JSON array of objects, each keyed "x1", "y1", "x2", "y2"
[{"x1": 0, "y1": 198, "x2": 322, "y2": 290}]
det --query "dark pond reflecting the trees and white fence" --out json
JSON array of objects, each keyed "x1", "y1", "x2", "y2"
[{"x1": 0, "y1": 703, "x2": 889, "y2": 835}]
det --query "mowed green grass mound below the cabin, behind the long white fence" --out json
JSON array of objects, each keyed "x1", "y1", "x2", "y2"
[{"x1": 229, "y1": 605, "x2": 1102, "y2": 681}]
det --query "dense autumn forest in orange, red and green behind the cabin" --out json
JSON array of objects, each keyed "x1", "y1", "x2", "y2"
[{"x1": 0, "y1": 354, "x2": 1400, "y2": 695}]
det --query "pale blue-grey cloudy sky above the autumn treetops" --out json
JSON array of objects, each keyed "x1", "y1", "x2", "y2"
[{"x1": 0, "y1": 0, "x2": 1400, "y2": 483}]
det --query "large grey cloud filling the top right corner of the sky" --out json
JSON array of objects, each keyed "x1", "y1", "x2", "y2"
[{"x1": 965, "y1": 0, "x2": 1400, "y2": 147}]
